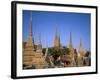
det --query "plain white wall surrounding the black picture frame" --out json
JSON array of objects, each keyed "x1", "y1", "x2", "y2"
[{"x1": 0, "y1": 0, "x2": 100, "y2": 80}]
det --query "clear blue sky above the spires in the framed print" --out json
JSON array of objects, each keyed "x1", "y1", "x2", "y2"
[{"x1": 22, "y1": 10, "x2": 91, "y2": 50}]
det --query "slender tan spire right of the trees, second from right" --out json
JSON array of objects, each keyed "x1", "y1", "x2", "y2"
[{"x1": 69, "y1": 32, "x2": 75, "y2": 66}]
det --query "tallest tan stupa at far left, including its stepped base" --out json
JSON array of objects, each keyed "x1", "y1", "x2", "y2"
[{"x1": 23, "y1": 12, "x2": 34, "y2": 66}]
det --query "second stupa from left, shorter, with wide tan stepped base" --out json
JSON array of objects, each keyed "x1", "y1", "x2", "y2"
[{"x1": 32, "y1": 33, "x2": 48, "y2": 69}]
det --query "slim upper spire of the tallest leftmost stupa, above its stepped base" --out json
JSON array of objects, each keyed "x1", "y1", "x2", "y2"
[{"x1": 26, "y1": 12, "x2": 34, "y2": 50}]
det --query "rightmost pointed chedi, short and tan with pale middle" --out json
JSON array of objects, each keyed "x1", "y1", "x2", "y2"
[{"x1": 78, "y1": 38, "x2": 84, "y2": 66}]
